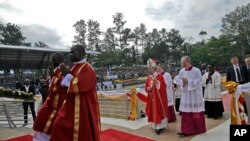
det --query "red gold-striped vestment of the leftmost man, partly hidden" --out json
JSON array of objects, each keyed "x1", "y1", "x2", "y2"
[{"x1": 33, "y1": 68, "x2": 67, "y2": 134}]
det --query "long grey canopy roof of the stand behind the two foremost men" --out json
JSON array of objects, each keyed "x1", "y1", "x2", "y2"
[{"x1": 0, "y1": 44, "x2": 100, "y2": 77}]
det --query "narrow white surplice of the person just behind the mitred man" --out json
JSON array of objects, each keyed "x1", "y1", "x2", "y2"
[{"x1": 163, "y1": 72, "x2": 174, "y2": 106}]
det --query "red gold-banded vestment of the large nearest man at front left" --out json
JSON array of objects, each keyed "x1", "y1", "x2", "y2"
[{"x1": 50, "y1": 63, "x2": 101, "y2": 141}]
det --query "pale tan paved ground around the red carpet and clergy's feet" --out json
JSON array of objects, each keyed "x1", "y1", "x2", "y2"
[{"x1": 0, "y1": 89, "x2": 230, "y2": 141}]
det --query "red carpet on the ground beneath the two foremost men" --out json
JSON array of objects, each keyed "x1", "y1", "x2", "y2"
[{"x1": 2, "y1": 129, "x2": 153, "y2": 141}]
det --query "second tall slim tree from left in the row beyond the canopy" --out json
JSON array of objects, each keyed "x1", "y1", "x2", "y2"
[{"x1": 87, "y1": 19, "x2": 101, "y2": 51}]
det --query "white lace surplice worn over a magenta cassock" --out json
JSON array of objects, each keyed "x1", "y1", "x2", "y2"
[{"x1": 177, "y1": 67, "x2": 205, "y2": 112}]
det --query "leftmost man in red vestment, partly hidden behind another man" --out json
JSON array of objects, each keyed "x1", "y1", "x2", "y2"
[{"x1": 33, "y1": 53, "x2": 67, "y2": 141}]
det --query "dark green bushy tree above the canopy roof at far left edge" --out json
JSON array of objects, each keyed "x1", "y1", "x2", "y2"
[{"x1": 0, "y1": 23, "x2": 26, "y2": 45}]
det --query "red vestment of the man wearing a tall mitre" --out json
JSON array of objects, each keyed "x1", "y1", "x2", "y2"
[{"x1": 145, "y1": 75, "x2": 168, "y2": 123}]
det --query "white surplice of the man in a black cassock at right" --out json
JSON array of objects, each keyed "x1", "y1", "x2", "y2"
[{"x1": 202, "y1": 71, "x2": 222, "y2": 101}]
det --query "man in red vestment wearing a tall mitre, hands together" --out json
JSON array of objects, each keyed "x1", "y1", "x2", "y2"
[{"x1": 145, "y1": 59, "x2": 168, "y2": 134}]
